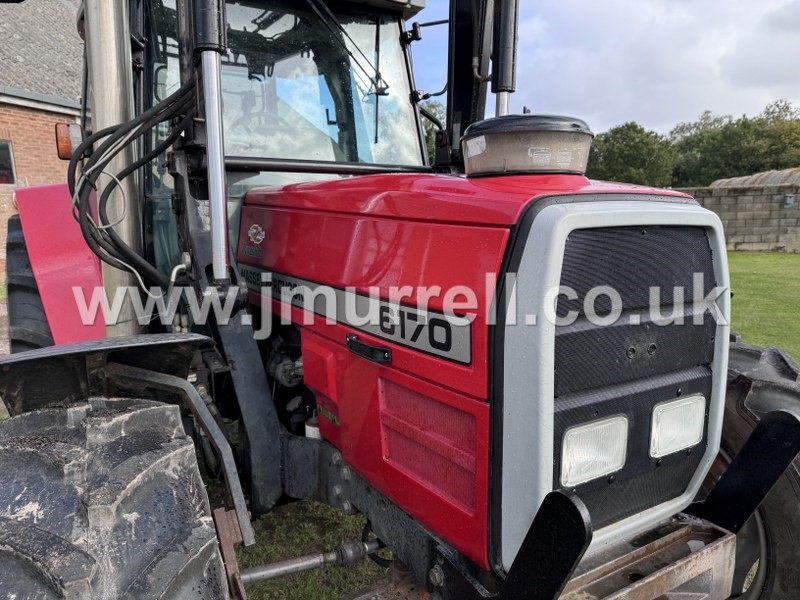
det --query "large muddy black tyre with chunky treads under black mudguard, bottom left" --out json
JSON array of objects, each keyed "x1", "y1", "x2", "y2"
[{"x1": 0, "y1": 399, "x2": 228, "y2": 600}]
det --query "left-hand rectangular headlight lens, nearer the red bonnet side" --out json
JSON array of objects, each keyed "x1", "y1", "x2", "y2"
[{"x1": 561, "y1": 415, "x2": 628, "y2": 487}]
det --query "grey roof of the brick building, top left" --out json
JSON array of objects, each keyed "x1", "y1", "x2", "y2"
[{"x1": 0, "y1": 0, "x2": 83, "y2": 102}]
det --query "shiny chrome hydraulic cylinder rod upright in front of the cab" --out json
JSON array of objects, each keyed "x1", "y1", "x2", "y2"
[{"x1": 201, "y1": 50, "x2": 229, "y2": 282}]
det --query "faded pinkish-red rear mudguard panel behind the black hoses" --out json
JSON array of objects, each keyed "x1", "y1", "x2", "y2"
[{"x1": 16, "y1": 184, "x2": 106, "y2": 344}]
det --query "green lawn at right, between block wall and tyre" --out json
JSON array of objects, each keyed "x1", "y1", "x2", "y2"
[{"x1": 728, "y1": 252, "x2": 800, "y2": 359}]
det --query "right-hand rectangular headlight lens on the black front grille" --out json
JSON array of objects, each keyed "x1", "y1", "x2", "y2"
[{"x1": 650, "y1": 394, "x2": 706, "y2": 458}]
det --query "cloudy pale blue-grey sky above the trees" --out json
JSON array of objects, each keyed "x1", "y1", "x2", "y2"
[{"x1": 413, "y1": 0, "x2": 800, "y2": 133}]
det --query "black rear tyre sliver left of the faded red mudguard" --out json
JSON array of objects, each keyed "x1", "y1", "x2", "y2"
[{"x1": 6, "y1": 215, "x2": 53, "y2": 354}]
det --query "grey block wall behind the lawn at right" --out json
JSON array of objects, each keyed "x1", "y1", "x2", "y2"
[{"x1": 681, "y1": 184, "x2": 800, "y2": 252}]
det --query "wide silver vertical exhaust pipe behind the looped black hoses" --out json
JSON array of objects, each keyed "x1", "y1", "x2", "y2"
[{"x1": 84, "y1": 0, "x2": 143, "y2": 337}]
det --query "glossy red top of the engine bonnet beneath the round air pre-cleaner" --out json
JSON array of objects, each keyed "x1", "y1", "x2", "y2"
[{"x1": 245, "y1": 174, "x2": 685, "y2": 227}]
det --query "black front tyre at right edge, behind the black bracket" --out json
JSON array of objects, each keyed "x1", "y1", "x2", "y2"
[{"x1": 715, "y1": 344, "x2": 800, "y2": 600}]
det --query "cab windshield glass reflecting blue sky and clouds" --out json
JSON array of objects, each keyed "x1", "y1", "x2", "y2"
[{"x1": 154, "y1": 0, "x2": 424, "y2": 166}]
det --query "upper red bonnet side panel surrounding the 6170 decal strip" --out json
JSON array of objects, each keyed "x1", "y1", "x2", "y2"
[{"x1": 239, "y1": 206, "x2": 509, "y2": 398}]
